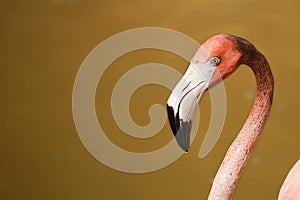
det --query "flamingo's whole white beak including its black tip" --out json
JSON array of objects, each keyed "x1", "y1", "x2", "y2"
[{"x1": 167, "y1": 61, "x2": 216, "y2": 152}]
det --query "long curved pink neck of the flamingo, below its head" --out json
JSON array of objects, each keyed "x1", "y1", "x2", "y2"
[{"x1": 208, "y1": 49, "x2": 274, "y2": 200}]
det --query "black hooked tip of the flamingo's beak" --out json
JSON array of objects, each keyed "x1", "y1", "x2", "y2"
[{"x1": 167, "y1": 104, "x2": 192, "y2": 153}]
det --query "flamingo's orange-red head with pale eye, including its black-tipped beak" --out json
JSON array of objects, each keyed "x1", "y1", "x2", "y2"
[{"x1": 167, "y1": 34, "x2": 246, "y2": 152}]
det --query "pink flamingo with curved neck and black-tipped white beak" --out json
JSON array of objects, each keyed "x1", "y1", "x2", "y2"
[{"x1": 167, "y1": 34, "x2": 300, "y2": 200}]
